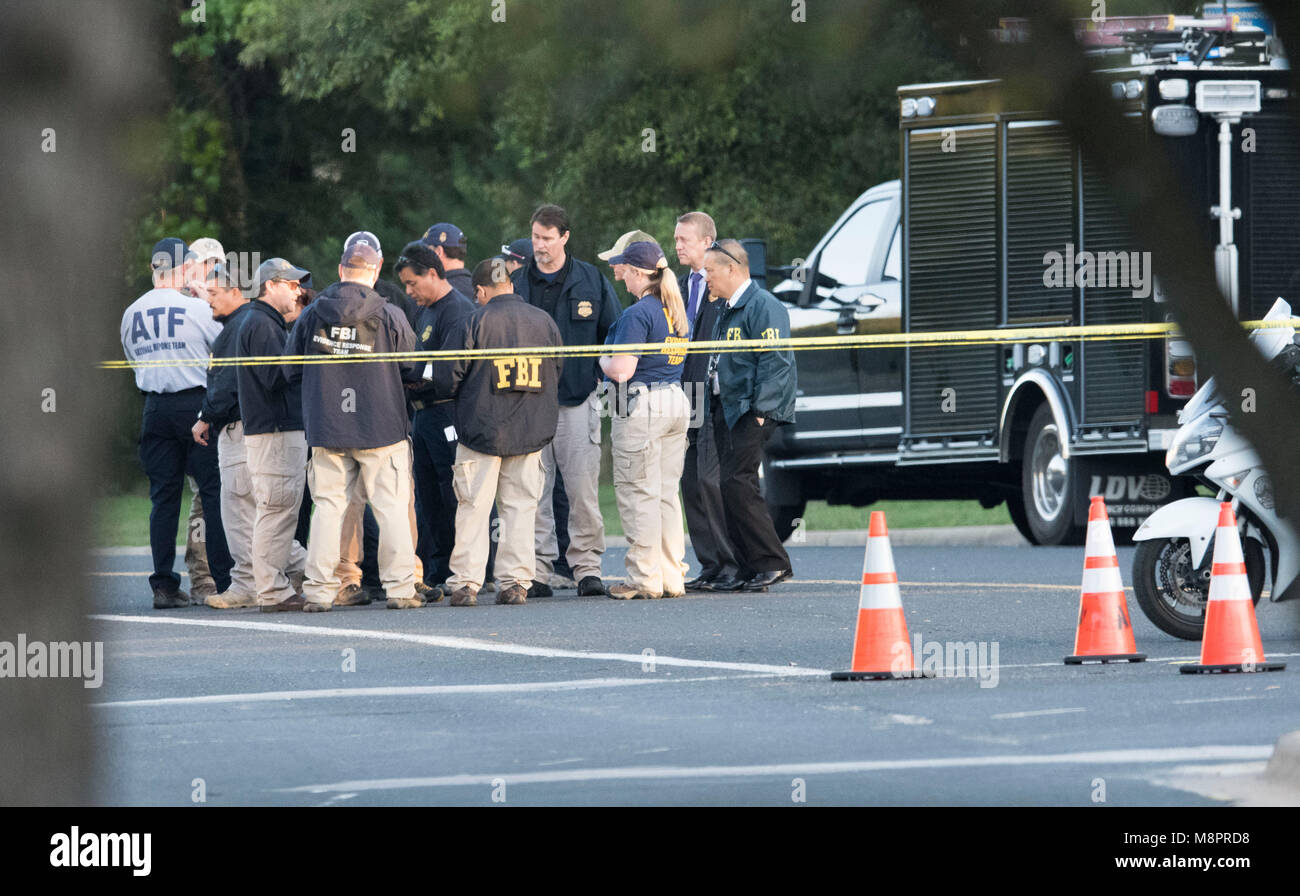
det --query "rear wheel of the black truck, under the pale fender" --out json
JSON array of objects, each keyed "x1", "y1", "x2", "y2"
[{"x1": 1011, "y1": 404, "x2": 1087, "y2": 545}]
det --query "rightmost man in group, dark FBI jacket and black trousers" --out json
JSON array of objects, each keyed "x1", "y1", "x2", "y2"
[{"x1": 705, "y1": 239, "x2": 796, "y2": 592}]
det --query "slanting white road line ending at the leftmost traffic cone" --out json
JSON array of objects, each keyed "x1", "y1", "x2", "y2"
[{"x1": 90, "y1": 614, "x2": 831, "y2": 678}]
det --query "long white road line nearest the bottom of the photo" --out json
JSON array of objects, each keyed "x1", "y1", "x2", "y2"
[{"x1": 277, "y1": 744, "x2": 1273, "y2": 793}]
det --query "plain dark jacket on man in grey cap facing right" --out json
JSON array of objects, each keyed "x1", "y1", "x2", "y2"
[{"x1": 235, "y1": 299, "x2": 303, "y2": 436}]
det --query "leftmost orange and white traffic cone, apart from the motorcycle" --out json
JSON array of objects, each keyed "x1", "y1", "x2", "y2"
[{"x1": 831, "y1": 510, "x2": 922, "y2": 681}]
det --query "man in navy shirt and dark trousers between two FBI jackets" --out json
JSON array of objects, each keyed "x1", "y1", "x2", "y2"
[{"x1": 393, "y1": 242, "x2": 476, "y2": 588}]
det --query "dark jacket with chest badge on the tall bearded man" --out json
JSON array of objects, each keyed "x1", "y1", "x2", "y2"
[{"x1": 512, "y1": 255, "x2": 623, "y2": 407}]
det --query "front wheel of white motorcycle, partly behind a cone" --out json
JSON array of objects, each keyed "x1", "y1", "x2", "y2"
[{"x1": 1134, "y1": 538, "x2": 1264, "y2": 641}]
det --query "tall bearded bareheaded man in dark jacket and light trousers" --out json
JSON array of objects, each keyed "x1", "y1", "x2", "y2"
[{"x1": 512, "y1": 205, "x2": 620, "y2": 596}]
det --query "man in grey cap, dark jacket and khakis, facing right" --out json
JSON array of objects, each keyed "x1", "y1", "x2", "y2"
[{"x1": 235, "y1": 259, "x2": 311, "y2": 613}]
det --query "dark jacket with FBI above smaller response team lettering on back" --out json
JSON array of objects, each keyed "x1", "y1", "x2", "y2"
[{"x1": 283, "y1": 282, "x2": 417, "y2": 449}]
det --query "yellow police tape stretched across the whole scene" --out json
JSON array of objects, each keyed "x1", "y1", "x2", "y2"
[{"x1": 99, "y1": 317, "x2": 1300, "y2": 371}]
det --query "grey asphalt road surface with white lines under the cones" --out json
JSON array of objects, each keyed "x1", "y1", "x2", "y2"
[{"x1": 86, "y1": 546, "x2": 1300, "y2": 806}]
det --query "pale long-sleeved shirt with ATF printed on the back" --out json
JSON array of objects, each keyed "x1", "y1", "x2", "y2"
[{"x1": 122, "y1": 289, "x2": 221, "y2": 393}]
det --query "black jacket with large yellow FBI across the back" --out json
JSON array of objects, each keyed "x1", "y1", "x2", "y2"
[{"x1": 433, "y1": 295, "x2": 563, "y2": 458}]
